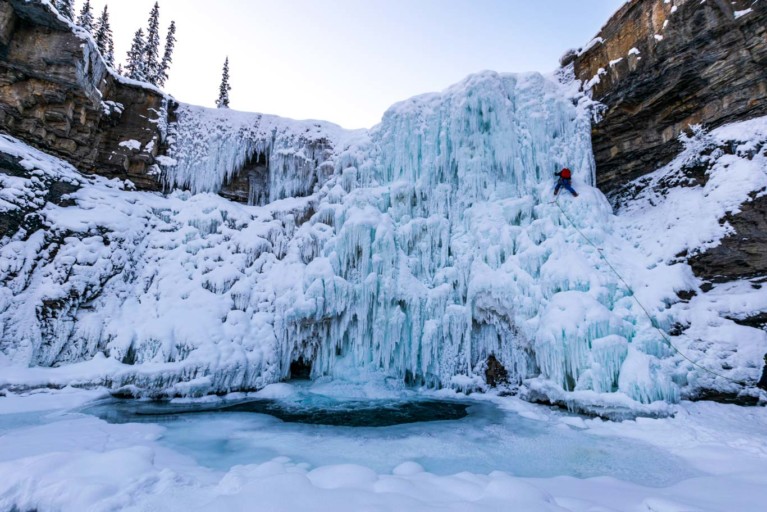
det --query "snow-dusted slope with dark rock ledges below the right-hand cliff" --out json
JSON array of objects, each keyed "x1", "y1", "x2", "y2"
[{"x1": 616, "y1": 117, "x2": 767, "y2": 396}]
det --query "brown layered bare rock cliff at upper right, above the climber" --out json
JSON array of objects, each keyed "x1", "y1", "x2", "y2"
[{"x1": 575, "y1": 0, "x2": 767, "y2": 194}]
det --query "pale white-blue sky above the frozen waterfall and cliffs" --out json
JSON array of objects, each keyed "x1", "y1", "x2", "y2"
[{"x1": 81, "y1": 0, "x2": 625, "y2": 128}]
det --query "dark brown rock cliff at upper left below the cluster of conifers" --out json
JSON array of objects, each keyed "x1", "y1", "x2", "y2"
[{"x1": 0, "y1": 0, "x2": 172, "y2": 190}]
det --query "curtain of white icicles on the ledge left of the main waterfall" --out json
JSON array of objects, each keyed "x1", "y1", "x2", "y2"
[{"x1": 161, "y1": 105, "x2": 354, "y2": 205}]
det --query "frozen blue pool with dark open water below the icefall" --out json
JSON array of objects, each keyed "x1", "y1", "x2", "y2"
[{"x1": 84, "y1": 388, "x2": 699, "y2": 487}]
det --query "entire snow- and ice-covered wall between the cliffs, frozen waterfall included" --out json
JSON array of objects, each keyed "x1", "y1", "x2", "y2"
[{"x1": 0, "y1": 72, "x2": 767, "y2": 403}]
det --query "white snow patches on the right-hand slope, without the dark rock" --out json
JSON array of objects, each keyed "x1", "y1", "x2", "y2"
[{"x1": 616, "y1": 117, "x2": 767, "y2": 394}]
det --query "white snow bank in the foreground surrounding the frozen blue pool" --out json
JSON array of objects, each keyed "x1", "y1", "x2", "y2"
[{"x1": 0, "y1": 390, "x2": 767, "y2": 512}]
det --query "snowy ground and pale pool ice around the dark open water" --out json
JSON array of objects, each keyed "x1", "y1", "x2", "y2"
[{"x1": 0, "y1": 385, "x2": 767, "y2": 512}]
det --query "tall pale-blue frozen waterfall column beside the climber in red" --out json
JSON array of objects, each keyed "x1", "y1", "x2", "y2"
[{"x1": 262, "y1": 69, "x2": 671, "y2": 398}]
